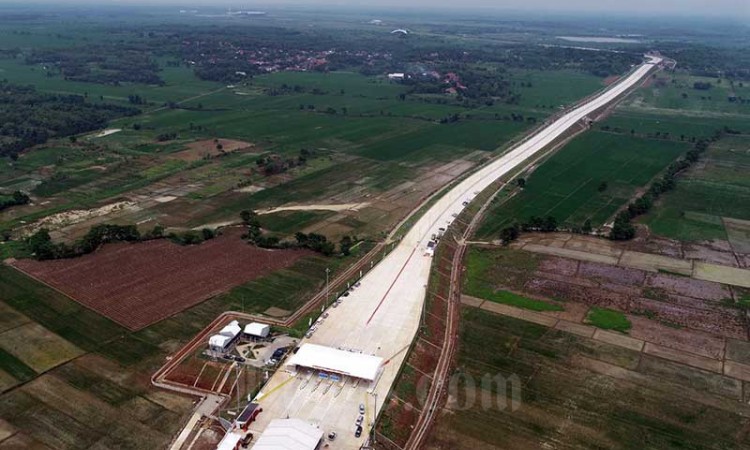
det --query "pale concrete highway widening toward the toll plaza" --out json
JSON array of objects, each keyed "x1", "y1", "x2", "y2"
[{"x1": 250, "y1": 57, "x2": 661, "y2": 449}]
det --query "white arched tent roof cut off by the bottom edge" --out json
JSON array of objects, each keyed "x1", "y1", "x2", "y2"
[{"x1": 253, "y1": 419, "x2": 323, "y2": 450}]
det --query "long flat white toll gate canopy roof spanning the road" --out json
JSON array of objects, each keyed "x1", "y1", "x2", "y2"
[{"x1": 288, "y1": 344, "x2": 383, "y2": 381}]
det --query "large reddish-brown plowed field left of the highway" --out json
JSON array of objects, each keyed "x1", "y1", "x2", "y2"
[{"x1": 13, "y1": 228, "x2": 308, "y2": 330}]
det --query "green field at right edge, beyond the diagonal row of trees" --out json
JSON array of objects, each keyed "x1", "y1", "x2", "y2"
[{"x1": 640, "y1": 136, "x2": 750, "y2": 244}]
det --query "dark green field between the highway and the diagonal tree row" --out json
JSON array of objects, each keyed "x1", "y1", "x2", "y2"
[{"x1": 477, "y1": 131, "x2": 689, "y2": 238}]
